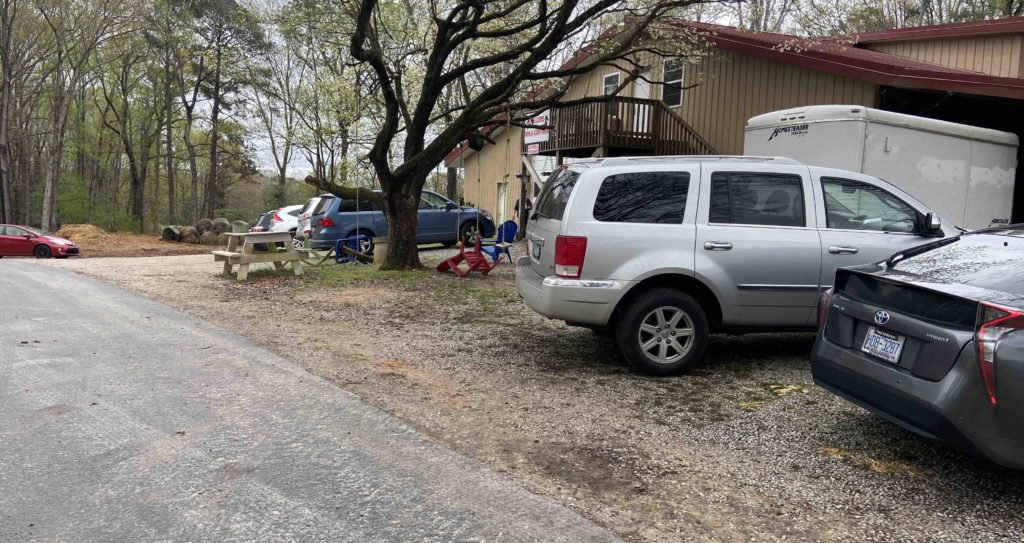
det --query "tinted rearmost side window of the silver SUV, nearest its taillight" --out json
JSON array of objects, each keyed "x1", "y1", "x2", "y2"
[{"x1": 594, "y1": 171, "x2": 690, "y2": 224}]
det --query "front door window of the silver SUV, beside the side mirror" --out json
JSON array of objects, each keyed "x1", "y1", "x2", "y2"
[{"x1": 821, "y1": 177, "x2": 918, "y2": 233}]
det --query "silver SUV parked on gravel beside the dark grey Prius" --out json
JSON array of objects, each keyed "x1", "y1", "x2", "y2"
[{"x1": 516, "y1": 157, "x2": 951, "y2": 375}]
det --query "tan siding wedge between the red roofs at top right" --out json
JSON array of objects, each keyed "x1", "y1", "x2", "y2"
[{"x1": 866, "y1": 34, "x2": 1024, "y2": 78}]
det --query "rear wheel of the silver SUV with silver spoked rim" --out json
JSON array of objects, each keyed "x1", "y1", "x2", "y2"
[{"x1": 615, "y1": 288, "x2": 709, "y2": 376}]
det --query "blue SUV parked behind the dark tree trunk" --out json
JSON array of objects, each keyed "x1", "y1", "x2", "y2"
[{"x1": 309, "y1": 191, "x2": 495, "y2": 253}]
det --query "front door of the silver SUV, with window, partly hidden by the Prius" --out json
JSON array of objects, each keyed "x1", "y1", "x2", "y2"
[{"x1": 813, "y1": 171, "x2": 933, "y2": 289}]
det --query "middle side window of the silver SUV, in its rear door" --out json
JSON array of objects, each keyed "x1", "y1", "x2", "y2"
[{"x1": 709, "y1": 172, "x2": 807, "y2": 226}]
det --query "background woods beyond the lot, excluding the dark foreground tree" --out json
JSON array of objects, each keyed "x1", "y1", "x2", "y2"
[{"x1": 0, "y1": 0, "x2": 1024, "y2": 232}]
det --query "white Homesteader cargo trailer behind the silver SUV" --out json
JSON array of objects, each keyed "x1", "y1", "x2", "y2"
[{"x1": 743, "y1": 106, "x2": 1018, "y2": 229}]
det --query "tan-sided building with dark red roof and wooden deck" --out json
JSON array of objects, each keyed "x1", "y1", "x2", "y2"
[{"x1": 445, "y1": 17, "x2": 1024, "y2": 221}]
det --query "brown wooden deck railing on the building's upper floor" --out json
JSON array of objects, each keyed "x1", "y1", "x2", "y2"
[{"x1": 523, "y1": 97, "x2": 717, "y2": 155}]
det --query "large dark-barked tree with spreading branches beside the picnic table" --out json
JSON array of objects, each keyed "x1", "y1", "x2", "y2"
[{"x1": 323, "y1": 0, "x2": 716, "y2": 269}]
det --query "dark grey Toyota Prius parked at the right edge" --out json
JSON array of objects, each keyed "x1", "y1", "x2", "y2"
[{"x1": 811, "y1": 224, "x2": 1024, "y2": 469}]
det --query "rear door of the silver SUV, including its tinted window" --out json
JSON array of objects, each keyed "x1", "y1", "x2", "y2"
[{"x1": 694, "y1": 165, "x2": 821, "y2": 328}]
